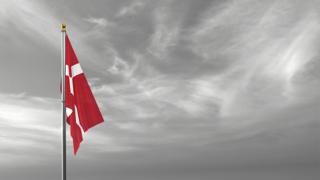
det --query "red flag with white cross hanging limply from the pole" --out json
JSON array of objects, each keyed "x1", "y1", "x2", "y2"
[{"x1": 65, "y1": 35, "x2": 103, "y2": 154}]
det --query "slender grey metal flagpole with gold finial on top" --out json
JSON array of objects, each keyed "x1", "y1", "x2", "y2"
[{"x1": 61, "y1": 24, "x2": 67, "y2": 180}]
